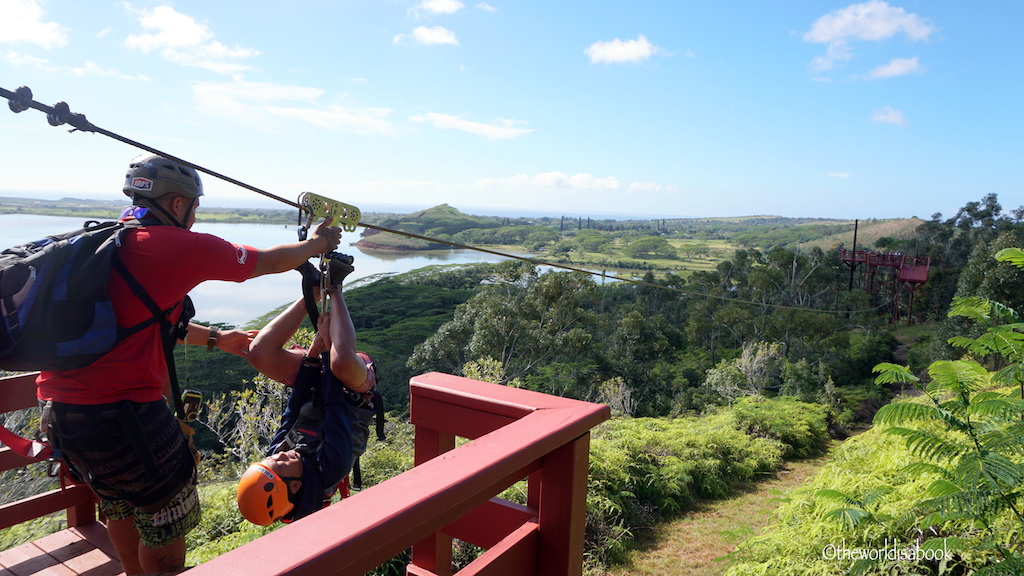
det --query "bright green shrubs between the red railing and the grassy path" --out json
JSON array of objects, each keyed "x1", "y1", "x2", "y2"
[{"x1": 587, "y1": 398, "x2": 828, "y2": 565}]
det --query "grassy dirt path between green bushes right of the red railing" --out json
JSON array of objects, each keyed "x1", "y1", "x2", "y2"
[{"x1": 607, "y1": 456, "x2": 828, "y2": 576}]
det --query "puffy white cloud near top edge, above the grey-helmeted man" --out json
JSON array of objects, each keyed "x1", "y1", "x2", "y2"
[{"x1": 125, "y1": 6, "x2": 260, "y2": 74}]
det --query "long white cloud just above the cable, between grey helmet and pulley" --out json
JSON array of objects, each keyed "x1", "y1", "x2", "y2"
[{"x1": 193, "y1": 78, "x2": 396, "y2": 135}]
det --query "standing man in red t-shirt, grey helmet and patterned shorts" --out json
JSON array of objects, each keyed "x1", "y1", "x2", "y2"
[{"x1": 37, "y1": 155, "x2": 341, "y2": 575}]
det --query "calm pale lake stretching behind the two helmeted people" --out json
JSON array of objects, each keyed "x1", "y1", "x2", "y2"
[{"x1": 0, "y1": 214, "x2": 506, "y2": 327}]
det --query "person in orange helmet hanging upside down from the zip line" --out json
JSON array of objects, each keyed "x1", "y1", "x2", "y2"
[{"x1": 238, "y1": 254, "x2": 380, "y2": 526}]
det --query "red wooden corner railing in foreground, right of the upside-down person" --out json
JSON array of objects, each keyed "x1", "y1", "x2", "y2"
[{"x1": 0, "y1": 366, "x2": 610, "y2": 576}]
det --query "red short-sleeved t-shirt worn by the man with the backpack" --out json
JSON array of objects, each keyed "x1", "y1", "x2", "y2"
[{"x1": 36, "y1": 225, "x2": 259, "y2": 404}]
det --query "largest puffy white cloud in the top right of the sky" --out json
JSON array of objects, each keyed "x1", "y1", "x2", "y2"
[{"x1": 803, "y1": 0, "x2": 935, "y2": 71}]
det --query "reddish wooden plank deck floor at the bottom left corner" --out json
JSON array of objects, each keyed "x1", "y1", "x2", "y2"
[{"x1": 0, "y1": 522, "x2": 124, "y2": 576}]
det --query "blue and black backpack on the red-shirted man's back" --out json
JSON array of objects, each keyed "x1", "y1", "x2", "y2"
[{"x1": 0, "y1": 220, "x2": 170, "y2": 370}]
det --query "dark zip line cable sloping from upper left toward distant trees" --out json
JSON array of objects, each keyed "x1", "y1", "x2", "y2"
[{"x1": 0, "y1": 86, "x2": 895, "y2": 314}]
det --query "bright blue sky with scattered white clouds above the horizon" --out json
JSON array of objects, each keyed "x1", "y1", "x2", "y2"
[{"x1": 0, "y1": 0, "x2": 1024, "y2": 218}]
